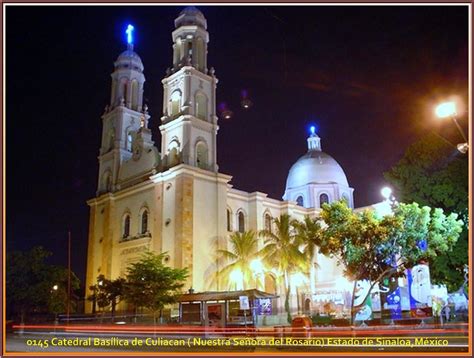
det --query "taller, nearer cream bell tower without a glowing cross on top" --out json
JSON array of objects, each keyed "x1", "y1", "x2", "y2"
[{"x1": 160, "y1": 6, "x2": 219, "y2": 172}]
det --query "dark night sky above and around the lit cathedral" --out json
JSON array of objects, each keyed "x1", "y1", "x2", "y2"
[{"x1": 6, "y1": 6, "x2": 468, "y2": 279}]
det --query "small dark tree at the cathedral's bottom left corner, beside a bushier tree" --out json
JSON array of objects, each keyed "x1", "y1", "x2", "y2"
[{"x1": 88, "y1": 275, "x2": 126, "y2": 320}]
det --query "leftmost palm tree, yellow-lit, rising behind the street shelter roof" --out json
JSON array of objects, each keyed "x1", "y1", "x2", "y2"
[{"x1": 217, "y1": 230, "x2": 258, "y2": 290}]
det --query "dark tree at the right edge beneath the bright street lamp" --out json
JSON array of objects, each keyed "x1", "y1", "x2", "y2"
[{"x1": 384, "y1": 133, "x2": 469, "y2": 291}]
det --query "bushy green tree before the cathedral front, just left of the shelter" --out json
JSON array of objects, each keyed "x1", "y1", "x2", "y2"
[{"x1": 125, "y1": 251, "x2": 188, "y2": 324}]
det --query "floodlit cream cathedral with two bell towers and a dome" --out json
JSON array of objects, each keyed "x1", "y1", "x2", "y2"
[{"x1": 86, "y1": 7, "x2": 382, "y2": 318}]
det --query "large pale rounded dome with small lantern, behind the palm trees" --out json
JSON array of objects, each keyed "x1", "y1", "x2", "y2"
[{"x1": 286, "y1": 135, "x2": 349, "y2": 190}]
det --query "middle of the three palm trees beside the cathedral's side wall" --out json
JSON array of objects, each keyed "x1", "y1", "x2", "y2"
[{"x1": 259, "y1": 214, "x2": 308, "y2": 322}]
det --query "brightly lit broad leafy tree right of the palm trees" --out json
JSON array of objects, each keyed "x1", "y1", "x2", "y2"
[{"x1": 321, "y1": 201, "x2": 463, "y2": 323}]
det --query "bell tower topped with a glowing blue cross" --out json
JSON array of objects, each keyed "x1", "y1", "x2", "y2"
[{"x1": 97, "y1": 25, "x2": 151, "y2": 195}]
